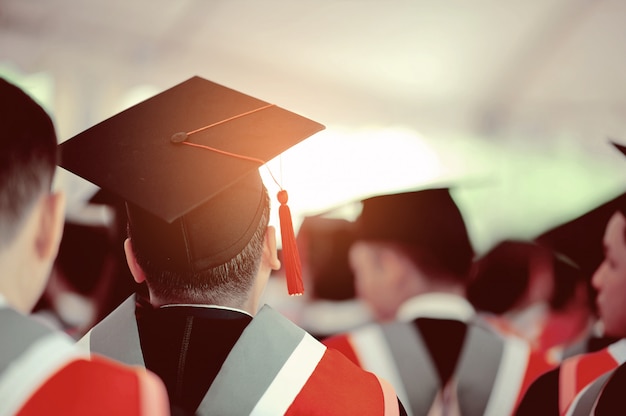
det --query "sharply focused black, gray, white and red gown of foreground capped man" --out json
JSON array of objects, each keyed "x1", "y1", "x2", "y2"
[{"x1": 81, "y1": 296, "x2": 400, "y2": 415}]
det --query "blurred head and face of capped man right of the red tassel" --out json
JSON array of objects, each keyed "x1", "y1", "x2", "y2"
[{"x1": 349, "y1": 188, "x2": 474, "y2": 320}]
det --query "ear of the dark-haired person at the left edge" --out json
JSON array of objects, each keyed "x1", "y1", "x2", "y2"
[{"x1": 35, "y1": 192, "x2": 65, "y2": 262}]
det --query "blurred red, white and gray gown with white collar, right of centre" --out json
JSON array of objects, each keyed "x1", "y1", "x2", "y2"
[{"x1": 323, "y1": 294, "x2": 551, "y2": 416}]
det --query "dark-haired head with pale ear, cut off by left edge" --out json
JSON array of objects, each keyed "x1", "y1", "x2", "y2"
[{"x1": 0, "y1": 79, "x2": 64, "y2": 312}]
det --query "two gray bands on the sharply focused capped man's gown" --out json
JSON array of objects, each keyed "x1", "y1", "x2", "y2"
[{"x1": 90, "y1": 295, "x2": 306, "y2": 415}]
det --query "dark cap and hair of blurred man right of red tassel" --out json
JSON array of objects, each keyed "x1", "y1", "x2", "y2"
[{"x1": 356, "y1": 188, "x2": 474, "y2": 283}]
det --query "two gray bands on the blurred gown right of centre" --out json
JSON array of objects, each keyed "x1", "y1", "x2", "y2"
[{"x1": 381, "y1": 322, "x2": 504, "y2": 416}]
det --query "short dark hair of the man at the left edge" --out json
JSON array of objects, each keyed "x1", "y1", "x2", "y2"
[{"x1": 0, "y1": 78, "x2": 57, "y2": 245}]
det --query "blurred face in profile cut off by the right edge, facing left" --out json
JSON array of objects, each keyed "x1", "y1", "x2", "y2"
[{"x1": 592, "y1": 211, "x2": 626, "y2": 338}]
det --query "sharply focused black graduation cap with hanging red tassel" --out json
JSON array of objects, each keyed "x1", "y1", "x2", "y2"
[{"x1": 59, "y1": 77, "x2": 324, "y2": 292}]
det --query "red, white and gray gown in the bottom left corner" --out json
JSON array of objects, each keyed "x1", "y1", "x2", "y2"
[{"x1": 0, "y1": 297, "x2": 169, "y2": 416}]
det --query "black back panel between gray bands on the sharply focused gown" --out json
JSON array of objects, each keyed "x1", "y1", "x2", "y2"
[{"x1": 137, "y1": 304, "x2": 252, "y2": 415}]
